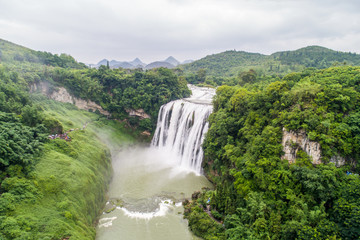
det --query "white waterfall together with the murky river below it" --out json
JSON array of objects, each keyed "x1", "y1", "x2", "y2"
[{"x1": 96, "y1": 86, "x2": 214, "y2": 240}]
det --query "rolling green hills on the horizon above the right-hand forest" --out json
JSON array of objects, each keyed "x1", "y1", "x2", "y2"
[{"x1": 181, "y1": 46, "x2": 360, "y2": 77}]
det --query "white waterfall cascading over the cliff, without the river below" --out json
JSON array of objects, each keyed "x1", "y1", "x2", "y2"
[{"x1": 151, "y1": 85, "x2": 215, "y2": 174}]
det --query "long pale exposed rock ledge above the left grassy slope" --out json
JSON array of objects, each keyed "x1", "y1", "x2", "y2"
[{"x1": 30, "y1": 82, "x2": 110, "y2": 116}]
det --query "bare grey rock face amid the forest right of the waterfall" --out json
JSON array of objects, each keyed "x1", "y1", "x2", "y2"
[{"x1": 282, "y1": 128, "x2": 321, "y2": 164}]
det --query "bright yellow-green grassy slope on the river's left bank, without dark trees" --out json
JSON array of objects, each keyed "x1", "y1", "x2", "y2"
[{"x1": 3, "y1": 100, "x2": 134, "y2": 239}]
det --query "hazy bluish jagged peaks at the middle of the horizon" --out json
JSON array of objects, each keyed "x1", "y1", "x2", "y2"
[{"x1": 90, "y1": 56, "x2": 192, "y2": 70}]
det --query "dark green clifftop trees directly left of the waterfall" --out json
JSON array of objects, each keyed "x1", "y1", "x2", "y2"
[{"x1": 48, "y1": 66, "x2": 190, "y2": 127}]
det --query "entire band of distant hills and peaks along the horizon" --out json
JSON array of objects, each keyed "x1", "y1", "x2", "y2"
[{"x1": 0, "y1": 39, "x2": 360, "y2": 77}]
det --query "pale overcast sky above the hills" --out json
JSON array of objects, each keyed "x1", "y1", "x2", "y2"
[{"x1": 0, "y1": 0, "x2": 360, "y2": 63}]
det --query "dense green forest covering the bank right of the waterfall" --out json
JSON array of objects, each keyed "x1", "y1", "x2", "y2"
[{"x1": 186, "y1": 67, "x2": 360, "y2": 239}]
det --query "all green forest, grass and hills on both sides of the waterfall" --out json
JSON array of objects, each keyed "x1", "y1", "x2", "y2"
[{"x1": 0, "y1": 40, "x2": 360, "y2": 240}]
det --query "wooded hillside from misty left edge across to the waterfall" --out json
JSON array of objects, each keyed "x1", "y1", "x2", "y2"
[{"x1": 0, "y1": 39, "x2": 190, "y2": 131}]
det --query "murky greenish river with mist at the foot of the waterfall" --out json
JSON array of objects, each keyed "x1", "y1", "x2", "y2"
[{"x1": 96, "y1": 148, "x2": 212, "y2": 240}]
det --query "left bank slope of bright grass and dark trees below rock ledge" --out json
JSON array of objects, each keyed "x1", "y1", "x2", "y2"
[{"x1": 0, "y1": 65, "x2": 134, "y2": 239}]
